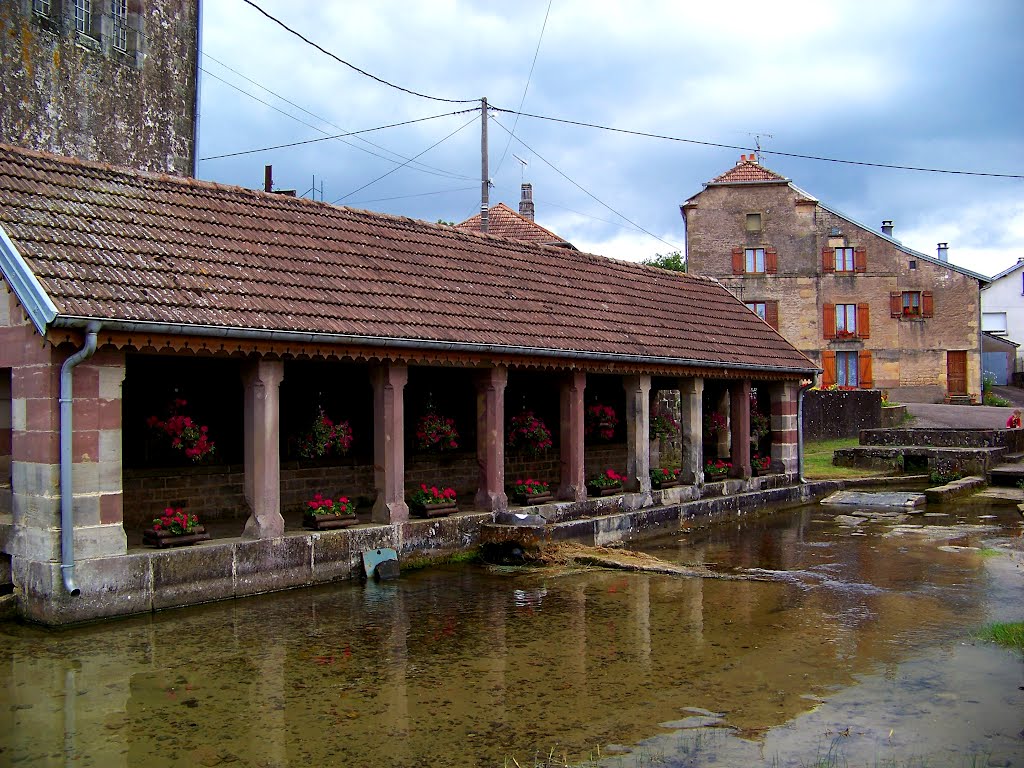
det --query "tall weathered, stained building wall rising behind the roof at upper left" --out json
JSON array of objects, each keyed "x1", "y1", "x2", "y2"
[{"x1": 0, "y1": 0, "x2": 200, "y2": 176}]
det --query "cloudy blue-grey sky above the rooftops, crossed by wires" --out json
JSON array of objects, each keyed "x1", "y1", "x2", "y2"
[{"x1": 199, "y1": 0, "x2": 1024, "y2": 275}]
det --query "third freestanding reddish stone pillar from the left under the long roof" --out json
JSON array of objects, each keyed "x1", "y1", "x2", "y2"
[{"x1": 474, "y1": 366, "x2": 509, "y2": 512}]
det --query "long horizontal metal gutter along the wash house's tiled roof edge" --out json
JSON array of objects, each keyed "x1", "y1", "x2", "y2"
[{"x1": 51, "y1": 315, "x2": 820, "y2": 377}]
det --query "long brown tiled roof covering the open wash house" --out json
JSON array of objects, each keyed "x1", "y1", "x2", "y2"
[{"x1": 0, "y1": 144, "x2": 814, "y2": 372}]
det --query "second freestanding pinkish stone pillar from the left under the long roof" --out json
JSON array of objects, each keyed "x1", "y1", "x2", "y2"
[{"x1": 371, "y1": 362, "x2": 409, "y2": 524}]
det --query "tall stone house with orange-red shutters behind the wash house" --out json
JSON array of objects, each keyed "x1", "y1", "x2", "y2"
[{"x1": 680, "y1": 155, "x2": 988, "y2": 402}]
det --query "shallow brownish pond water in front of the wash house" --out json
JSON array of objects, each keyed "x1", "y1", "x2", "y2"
[{"x1": 0, "y1": 495, "x2": 1024, "y2": 768}]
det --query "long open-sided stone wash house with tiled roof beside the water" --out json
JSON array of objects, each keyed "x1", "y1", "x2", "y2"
[{"x1": 0, "y1": 145, "x2": 816, "y2": 624}]
